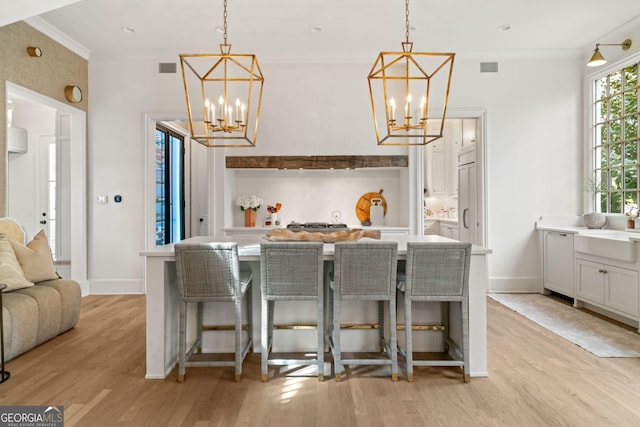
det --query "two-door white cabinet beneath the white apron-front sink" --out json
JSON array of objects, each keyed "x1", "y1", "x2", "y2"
[{"x1": 576, "y1": 258, "x2": 639, "y2": 320}]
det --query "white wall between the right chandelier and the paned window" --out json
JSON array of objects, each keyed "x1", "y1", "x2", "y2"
[{"x1": 451, "y1": 57, "x2": 583, "y2": 291}]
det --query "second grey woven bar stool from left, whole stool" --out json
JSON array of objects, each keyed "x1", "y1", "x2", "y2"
[{"x1": 260, "y1": 242, "x2": 324, "y2": 381}]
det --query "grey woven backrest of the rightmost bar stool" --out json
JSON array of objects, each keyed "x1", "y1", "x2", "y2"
[{"x1": 405, "y1": 242, "x2": 471, "y2": 297}]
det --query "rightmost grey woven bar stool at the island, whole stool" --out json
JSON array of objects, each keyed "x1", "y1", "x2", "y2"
[{"x1": 398, "y1": 242, "x2": 471, "y2": 382}]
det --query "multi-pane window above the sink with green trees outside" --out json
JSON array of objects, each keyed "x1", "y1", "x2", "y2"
[{"x1": 591, "y1": 62, "x2": 639, "y2": 213}]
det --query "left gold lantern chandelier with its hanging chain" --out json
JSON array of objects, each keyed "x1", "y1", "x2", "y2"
[{"x1": 179, "y1": 0, "x2": 264, "y2": 147}]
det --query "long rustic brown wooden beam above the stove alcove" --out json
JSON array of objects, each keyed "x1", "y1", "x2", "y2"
[{"x1": 226, "y1": 155, "x2": 409, "y2": 169}]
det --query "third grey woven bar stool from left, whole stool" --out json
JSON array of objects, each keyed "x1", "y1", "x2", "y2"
[{"x1": 329, "y1": 242, "x2": 398, "y2": 381}]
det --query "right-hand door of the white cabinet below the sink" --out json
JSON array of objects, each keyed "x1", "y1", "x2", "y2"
[{"x1": 604, "y1": 265, "x2": 638, "y2": 316}]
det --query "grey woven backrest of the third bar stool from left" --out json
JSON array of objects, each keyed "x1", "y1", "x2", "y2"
[{"x1": 333, "y1": 242, "x2": 398, "y2": 300}]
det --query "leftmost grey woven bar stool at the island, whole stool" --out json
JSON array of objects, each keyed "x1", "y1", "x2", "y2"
[{"x1": 174, "y1": 243, "x2": 253, "y2": 382}]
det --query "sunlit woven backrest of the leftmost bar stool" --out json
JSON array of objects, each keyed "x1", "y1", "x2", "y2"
[{"x1": 174, "y1": 242, "x2": 240, "y2": 301}]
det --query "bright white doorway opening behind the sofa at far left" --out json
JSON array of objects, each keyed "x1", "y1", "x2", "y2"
[{"x1": 6, "y1": 82, "x2": 88, "y2": 288}]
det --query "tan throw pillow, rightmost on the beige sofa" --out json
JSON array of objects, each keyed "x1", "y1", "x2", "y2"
[{"x1": 11, "y1": 230, "x2": 59, "y2": 283}]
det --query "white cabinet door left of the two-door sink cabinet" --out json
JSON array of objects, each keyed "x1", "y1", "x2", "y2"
[{"x1": 543, "y1": 231, "x2": 575, "y2": 298}]
